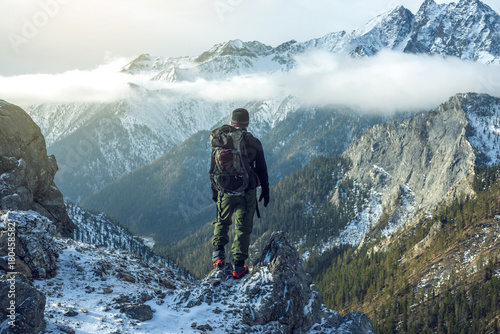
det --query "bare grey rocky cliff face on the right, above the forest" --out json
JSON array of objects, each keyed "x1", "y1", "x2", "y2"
[{"x1": 331, "y1": 94, "x2": 500, "y2": 249}]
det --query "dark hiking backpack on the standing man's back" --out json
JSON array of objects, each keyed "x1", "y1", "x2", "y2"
[{"x1": 210, "y1": 125, "x2": 250, "y2": 196}]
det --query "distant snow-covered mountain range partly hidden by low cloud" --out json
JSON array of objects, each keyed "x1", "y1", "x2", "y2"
[{"x1": 25, "y1": 1, "x2": 500, "y2": 202}]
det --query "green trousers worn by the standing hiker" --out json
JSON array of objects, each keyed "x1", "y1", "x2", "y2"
[{"x1": 212, "y1": 189, "x2": 257, "y2": 262}]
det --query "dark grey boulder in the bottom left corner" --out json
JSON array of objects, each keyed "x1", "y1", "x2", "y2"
[{"x1": 0, "y1": 275, "x2": 45, "y2": 334}]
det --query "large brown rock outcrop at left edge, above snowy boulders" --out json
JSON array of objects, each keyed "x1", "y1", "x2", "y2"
[{"x1": 0, "y1": 100, "x2": 74, "y2": 236}]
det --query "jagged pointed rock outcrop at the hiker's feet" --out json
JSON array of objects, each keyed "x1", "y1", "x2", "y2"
[{"x1": 178, "y1": 232, "x2": 375, "y2": 334}]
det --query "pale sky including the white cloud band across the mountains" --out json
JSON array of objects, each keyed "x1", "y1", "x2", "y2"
[{"x1": 0, "y1": 0, "x2": 500, "y2": 112}]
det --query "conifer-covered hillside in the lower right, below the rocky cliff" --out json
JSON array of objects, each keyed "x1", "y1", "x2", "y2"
[{"x1": 306, "y1": 166, "x2": 500, "y2": 334}]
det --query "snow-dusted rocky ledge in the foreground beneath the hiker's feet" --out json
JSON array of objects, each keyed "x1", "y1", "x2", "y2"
[{"x1": 0, "y1": 211, "x2": 374, "y2": 334}]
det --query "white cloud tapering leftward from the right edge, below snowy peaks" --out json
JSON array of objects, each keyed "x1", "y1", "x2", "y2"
[{"x1": 159, "y1": 51, "x2": 500, "y2": 113}]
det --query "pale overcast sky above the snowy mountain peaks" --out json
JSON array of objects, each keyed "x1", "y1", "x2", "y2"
[{"x1": 0, "y1": 0, "x2": 500, "y2": 76}]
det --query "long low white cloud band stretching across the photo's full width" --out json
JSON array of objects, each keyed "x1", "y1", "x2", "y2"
[{"x1": 0, "y1": 51, "x2": 500, "y2": 113}]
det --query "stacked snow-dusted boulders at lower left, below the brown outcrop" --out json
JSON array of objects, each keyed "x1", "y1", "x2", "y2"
[{"x1": 0, "y1": 210, "x2": 59, "y2": 334}]
